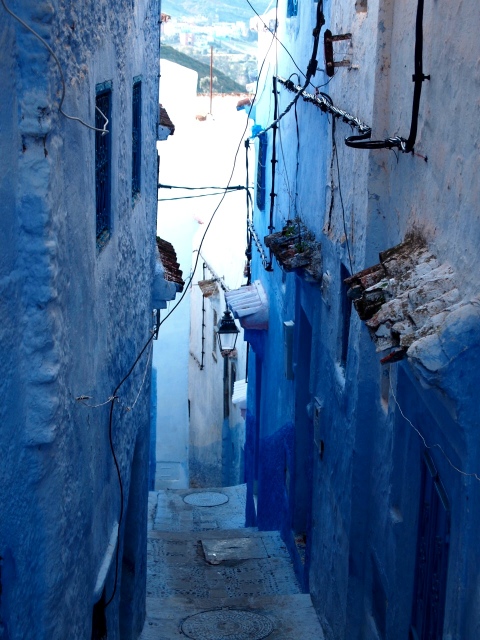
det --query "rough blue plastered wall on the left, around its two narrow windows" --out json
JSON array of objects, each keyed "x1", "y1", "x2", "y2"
[{"x1": 0, "y1": 0, "x2": 159, "y2": 640}]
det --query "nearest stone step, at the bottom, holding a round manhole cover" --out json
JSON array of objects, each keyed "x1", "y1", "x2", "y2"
[{"x1": 140, "y1": 594, "x2": 324, "y2": 640}]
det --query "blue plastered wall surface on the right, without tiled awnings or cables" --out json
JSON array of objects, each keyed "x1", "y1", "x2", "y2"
[{"x1": 246, "y1": 0, "x2": 480, "y2": 640}]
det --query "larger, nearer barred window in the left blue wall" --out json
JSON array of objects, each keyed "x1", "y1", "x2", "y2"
[{"x1": 95, "y1": 82, "x2": 112, "y2": 248}]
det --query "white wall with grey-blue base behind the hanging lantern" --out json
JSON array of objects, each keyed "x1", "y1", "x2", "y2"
[{"x1": 189, "y1": 254, "x2": 246, "y2": 487}]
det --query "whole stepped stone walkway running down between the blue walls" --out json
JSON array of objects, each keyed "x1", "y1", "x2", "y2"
[{"x1": 140, "y1": 485, "x2": 323, "y2": 640}]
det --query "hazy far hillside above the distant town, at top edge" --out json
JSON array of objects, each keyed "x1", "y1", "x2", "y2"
[{"x1": 162, "y1": 0, "x2": 274, "y2": 22}]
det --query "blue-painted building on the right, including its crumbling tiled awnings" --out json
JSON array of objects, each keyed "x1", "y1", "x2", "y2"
[{"x1": 245, "y1": 0, "x2": 480, "y2": 640}]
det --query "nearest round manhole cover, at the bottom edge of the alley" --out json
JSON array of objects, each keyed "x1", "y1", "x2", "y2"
[{"x1": 182, "y1": 609, "x2": 273, "y2": 640}]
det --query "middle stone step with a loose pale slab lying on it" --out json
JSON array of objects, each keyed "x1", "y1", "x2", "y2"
[{"x1": 147, "y1": 529, "x2": 301, "y2": 598}]
